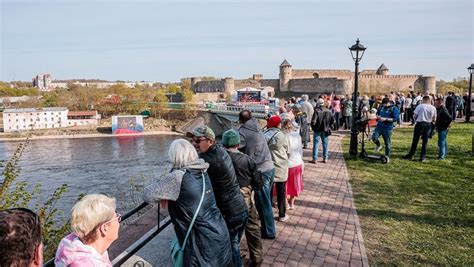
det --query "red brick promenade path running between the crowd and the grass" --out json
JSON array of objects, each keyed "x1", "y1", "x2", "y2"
[{"x1": 122, "y1": 134, "x2": 368, "y2": 267}]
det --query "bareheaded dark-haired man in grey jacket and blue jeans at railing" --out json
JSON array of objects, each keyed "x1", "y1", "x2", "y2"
[{"x1": 239, "y1": 110, "x2": 276, "y2": 239}]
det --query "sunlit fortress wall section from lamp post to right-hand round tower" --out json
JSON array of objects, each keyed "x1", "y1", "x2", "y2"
[{"x1": 359, "y1": 75, "x2": 420, "y2": 94}]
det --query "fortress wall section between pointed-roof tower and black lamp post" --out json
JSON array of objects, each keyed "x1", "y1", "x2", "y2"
[{"x1": 289, "y1": 78, "x2": 352, "y2": 95}]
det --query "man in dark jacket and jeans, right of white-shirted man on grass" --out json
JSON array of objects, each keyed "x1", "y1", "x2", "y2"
[{"x1": 435, "y1": 98, "x2": 453, "y2": 160}]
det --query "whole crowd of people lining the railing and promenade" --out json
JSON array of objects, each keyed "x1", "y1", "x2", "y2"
[{"x1": 0, "y1": 92, "x2": 463, "y2": 266}]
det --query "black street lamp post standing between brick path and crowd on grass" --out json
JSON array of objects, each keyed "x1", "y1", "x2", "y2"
[{"x1": 349, "y1": 38, "x2": 367, "y2": 157}]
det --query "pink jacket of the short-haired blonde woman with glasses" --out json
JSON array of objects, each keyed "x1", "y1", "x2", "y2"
[{"x1": 54, "y1": 234, "x2": 112, "y2": 267}]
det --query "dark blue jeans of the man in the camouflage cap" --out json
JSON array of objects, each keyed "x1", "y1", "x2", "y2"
[{"x1": 224, "y1": 211, "x2": 249, "y2": 266}]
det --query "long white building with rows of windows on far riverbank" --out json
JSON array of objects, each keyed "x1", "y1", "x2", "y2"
[{"x1": 3, "y1": 108, "x2": 68, "y2": 132}]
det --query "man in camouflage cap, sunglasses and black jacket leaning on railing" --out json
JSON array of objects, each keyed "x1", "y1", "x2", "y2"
[{"x1": 186, "y1": 126, "x2": 248, "y2": 266}]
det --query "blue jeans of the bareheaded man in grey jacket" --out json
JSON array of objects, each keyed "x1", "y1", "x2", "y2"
[{"x1": 255, "y1": 169, "x2": 276, "y2": 239}]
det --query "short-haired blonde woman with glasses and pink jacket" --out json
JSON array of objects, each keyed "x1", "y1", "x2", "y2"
[{"x1": 54, "y1": 194, "x2": 121, "y2": 267}]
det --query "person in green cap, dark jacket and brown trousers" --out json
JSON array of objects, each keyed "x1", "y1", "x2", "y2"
[{"x1": 222, "y1": 129, "x2": 263, "y2": 266}]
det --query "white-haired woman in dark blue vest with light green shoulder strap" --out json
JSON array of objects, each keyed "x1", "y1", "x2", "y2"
[{"x1": 143, "y1": 139, "x2": 232, "y2": 266}]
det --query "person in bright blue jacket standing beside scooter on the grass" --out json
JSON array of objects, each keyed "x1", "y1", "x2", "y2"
[{"x1": 372, "y1": 97, "x2": 400, "y2": 160}]
